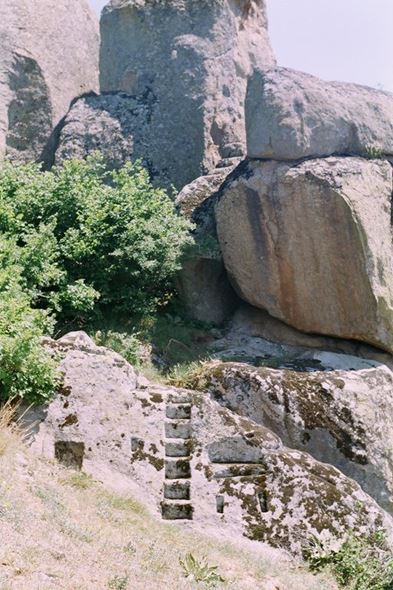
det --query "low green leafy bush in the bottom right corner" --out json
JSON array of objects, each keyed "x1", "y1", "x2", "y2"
[{"x1": 306, "y1": 533, "x2": 393, "y2": 590}]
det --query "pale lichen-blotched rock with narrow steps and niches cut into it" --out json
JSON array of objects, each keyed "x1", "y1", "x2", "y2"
[{"x1": 29, "y1": 335, "x2": 391, "y2": 553}]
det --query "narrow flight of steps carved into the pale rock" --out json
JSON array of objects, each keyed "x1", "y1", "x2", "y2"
[{"x1": 161, "y1": 393, "x2": 193, "y2": 520}]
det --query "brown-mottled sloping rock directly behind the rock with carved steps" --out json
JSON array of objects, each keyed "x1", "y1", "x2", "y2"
[{"x1": 199, "y1": 360, "x2": 393, "y2": 512}]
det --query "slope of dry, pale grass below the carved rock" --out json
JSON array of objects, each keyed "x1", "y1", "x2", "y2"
[{"x1": 0, "y1": 424, "x2": 335, "y2": 590}]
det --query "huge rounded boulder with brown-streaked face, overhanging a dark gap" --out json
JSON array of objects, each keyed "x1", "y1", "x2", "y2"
[{"x1": 216, "y1": 157, "x2": 393, "y2": 352}]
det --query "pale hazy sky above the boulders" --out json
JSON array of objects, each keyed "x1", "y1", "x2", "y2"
[{"x1": 90, "y1": 0, "x2": 393, "y2": 92}]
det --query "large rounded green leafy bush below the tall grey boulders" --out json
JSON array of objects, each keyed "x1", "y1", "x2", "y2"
[{"x1": 0, "y1": 155, "x2": 191, "y2": 324}]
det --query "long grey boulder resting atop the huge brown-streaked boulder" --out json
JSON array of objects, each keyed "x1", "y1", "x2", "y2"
[{"x1": 246, "y1": 68, "x2": 393, "y2": 160}]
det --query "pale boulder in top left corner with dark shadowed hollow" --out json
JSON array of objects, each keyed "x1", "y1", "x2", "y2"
[{"x1": 0, "y1": 0, "x2": 99, "y2": 160}]
